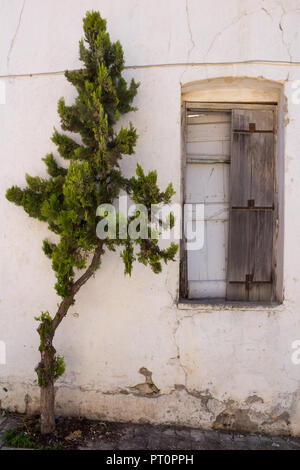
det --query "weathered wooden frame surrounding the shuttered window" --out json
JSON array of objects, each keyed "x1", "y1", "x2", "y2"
[{"x1": 178, "y1": 101, "x2": 283, "y2": 306}]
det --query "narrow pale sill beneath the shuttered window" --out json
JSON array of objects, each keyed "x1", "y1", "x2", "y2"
[{"x1": 177, "y1": 299, "x2": 284, "y2": 312}]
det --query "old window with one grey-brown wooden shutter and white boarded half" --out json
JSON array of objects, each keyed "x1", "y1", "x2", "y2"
[{"x1": 181, "y1": 103, "x2": 278, "y2": 302}]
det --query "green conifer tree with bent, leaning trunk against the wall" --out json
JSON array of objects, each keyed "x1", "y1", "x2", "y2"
[{"x1": 6, "y1": 11, "x2": 177, "y2": 433}]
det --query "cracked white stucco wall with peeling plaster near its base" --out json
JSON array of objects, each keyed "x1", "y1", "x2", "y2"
[{"x1": 0, "y1": 0, "x2": 300, "y2": 434}]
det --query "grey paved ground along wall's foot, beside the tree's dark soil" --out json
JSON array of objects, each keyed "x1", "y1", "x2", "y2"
[{"x1": 0, "y1": 415, "x2": 300, "y2": 450}]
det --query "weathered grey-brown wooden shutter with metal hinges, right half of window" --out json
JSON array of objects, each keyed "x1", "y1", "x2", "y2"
[{"x1": 227, "y1": 109, "x2": 275, "y2": 301}]
